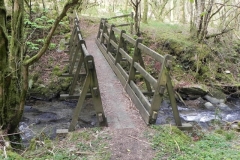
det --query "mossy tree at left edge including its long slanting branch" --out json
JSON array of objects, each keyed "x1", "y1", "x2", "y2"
[{"x1": 0, "y1": 0, "x2": 81, "y2": 146}]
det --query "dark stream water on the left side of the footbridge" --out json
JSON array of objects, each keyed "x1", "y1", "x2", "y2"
[{"x1": 19, "y1": 100, "x2": 97, "y2": 145}]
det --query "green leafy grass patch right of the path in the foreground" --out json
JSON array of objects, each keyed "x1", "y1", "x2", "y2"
[{"x1": 149, "y1": 126, "x2": 240, "y2": 160}]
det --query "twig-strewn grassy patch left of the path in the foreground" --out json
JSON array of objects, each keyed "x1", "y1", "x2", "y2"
[{"x1": 20, "y1": 128, "x2": 111, "y2": 160}]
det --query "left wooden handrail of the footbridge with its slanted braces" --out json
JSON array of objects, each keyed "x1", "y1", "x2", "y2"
[{"x1": 60, "y1": 11, "x2": 107, "y2": 131}]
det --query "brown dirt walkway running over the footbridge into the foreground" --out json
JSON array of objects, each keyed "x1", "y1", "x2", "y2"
[{"x1": 85, "y1": 24, "x2": 154, "y2": 160}]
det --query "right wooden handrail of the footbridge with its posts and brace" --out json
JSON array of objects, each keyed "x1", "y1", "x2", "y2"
[{"x1": 96, "y1": 18, "x2": 191, "y2": 128}]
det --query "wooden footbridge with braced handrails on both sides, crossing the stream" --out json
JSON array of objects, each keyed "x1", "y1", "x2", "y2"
[{"x1": 61, "y1": 11, "x2": 191, "y2": 131}]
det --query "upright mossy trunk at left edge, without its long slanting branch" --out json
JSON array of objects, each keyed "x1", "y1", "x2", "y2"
[{"x1": 0, "y1": 0, "x2": 27, "y2": 141}]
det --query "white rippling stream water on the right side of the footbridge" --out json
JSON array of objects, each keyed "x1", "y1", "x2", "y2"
[{"x1": 156, "y1": 98, "x2": 240, "y2": 129}]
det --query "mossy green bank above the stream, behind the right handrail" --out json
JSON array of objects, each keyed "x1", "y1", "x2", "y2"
[{"x1": 142, "y1": 21, "x2": 240, "y2": 94}]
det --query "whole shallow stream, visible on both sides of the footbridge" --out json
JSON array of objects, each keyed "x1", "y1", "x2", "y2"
[{"x1": 19, "y1": 98, "x2": 240, "y2": 146}]
